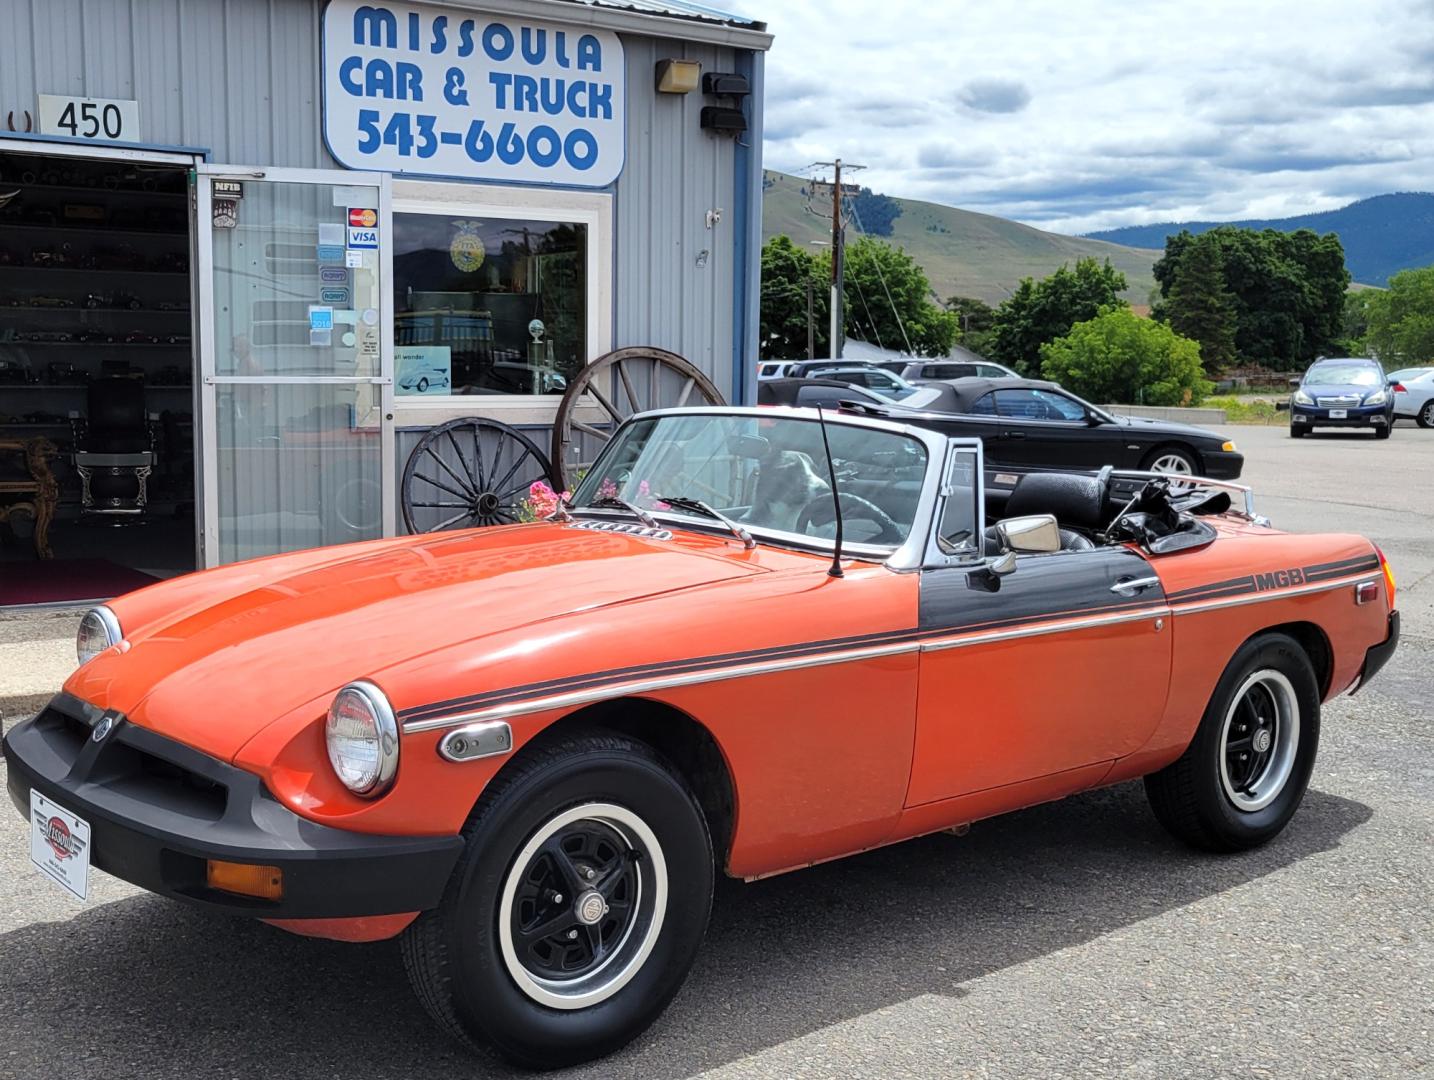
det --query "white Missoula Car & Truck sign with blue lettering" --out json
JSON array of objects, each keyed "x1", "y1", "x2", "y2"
[{"x1": 324, "y1": 0, "x2": 627, "y2": 188}]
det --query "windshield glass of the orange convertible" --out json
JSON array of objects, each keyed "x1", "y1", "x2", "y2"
[{"x1": 572, "y1": 413, "x2": 926, "y2": 549}]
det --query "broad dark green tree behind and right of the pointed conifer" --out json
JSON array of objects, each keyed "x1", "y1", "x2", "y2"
[{"x1": 1154, "y1": 225, "x2": 1349, "y2": 370}]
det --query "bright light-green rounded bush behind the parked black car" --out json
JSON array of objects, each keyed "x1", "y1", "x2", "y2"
[{"x1": 1041, "y1": 307, "x2": 1215, "y2": 404}]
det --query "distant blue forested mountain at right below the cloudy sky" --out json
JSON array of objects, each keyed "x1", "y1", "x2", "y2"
[{"x1": 1093, "y1": 192, "x2": 1434, "y2": 285}]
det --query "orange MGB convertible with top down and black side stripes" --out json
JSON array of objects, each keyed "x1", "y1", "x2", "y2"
[{"x1": 4, "y1": 407, "x2": 1398, "y2": 1066}]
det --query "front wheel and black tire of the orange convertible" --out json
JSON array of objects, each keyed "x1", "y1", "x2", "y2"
[{"x1": 403, "y1": 734, "x2": 713, "y2": 1069}]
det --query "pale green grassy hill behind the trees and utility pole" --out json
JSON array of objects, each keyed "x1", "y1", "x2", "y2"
[{"x1": 761, "y1": 171, "x2": 1160, "y2": 304}]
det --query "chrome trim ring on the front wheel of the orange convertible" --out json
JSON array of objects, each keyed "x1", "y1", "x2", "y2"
[{"x1": 498, "y1": 803, "x2": 667, "y2": 1010}]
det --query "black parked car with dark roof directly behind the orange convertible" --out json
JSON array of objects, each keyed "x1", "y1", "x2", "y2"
[{"x1": 860, "y1": 379, "x2": 1245, "y2": 498}]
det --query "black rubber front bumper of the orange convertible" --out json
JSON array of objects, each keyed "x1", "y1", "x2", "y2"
[{"x1": 3, "y1": 694, "x2": 463, "y2": 919}]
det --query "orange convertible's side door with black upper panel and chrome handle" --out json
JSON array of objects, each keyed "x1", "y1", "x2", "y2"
[{"x1": 906, "y1": 441, "x2": 1172, "y2": 806}]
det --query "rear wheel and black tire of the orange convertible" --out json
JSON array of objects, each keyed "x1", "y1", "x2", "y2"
[{"x1": 1146, "y1": 634, "x2": 1319, "y2": 852}]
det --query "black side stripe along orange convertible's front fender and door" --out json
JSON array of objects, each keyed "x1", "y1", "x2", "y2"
[{"x1": 399, "y1": 598, "x2": 1152, "y2": 723}]
